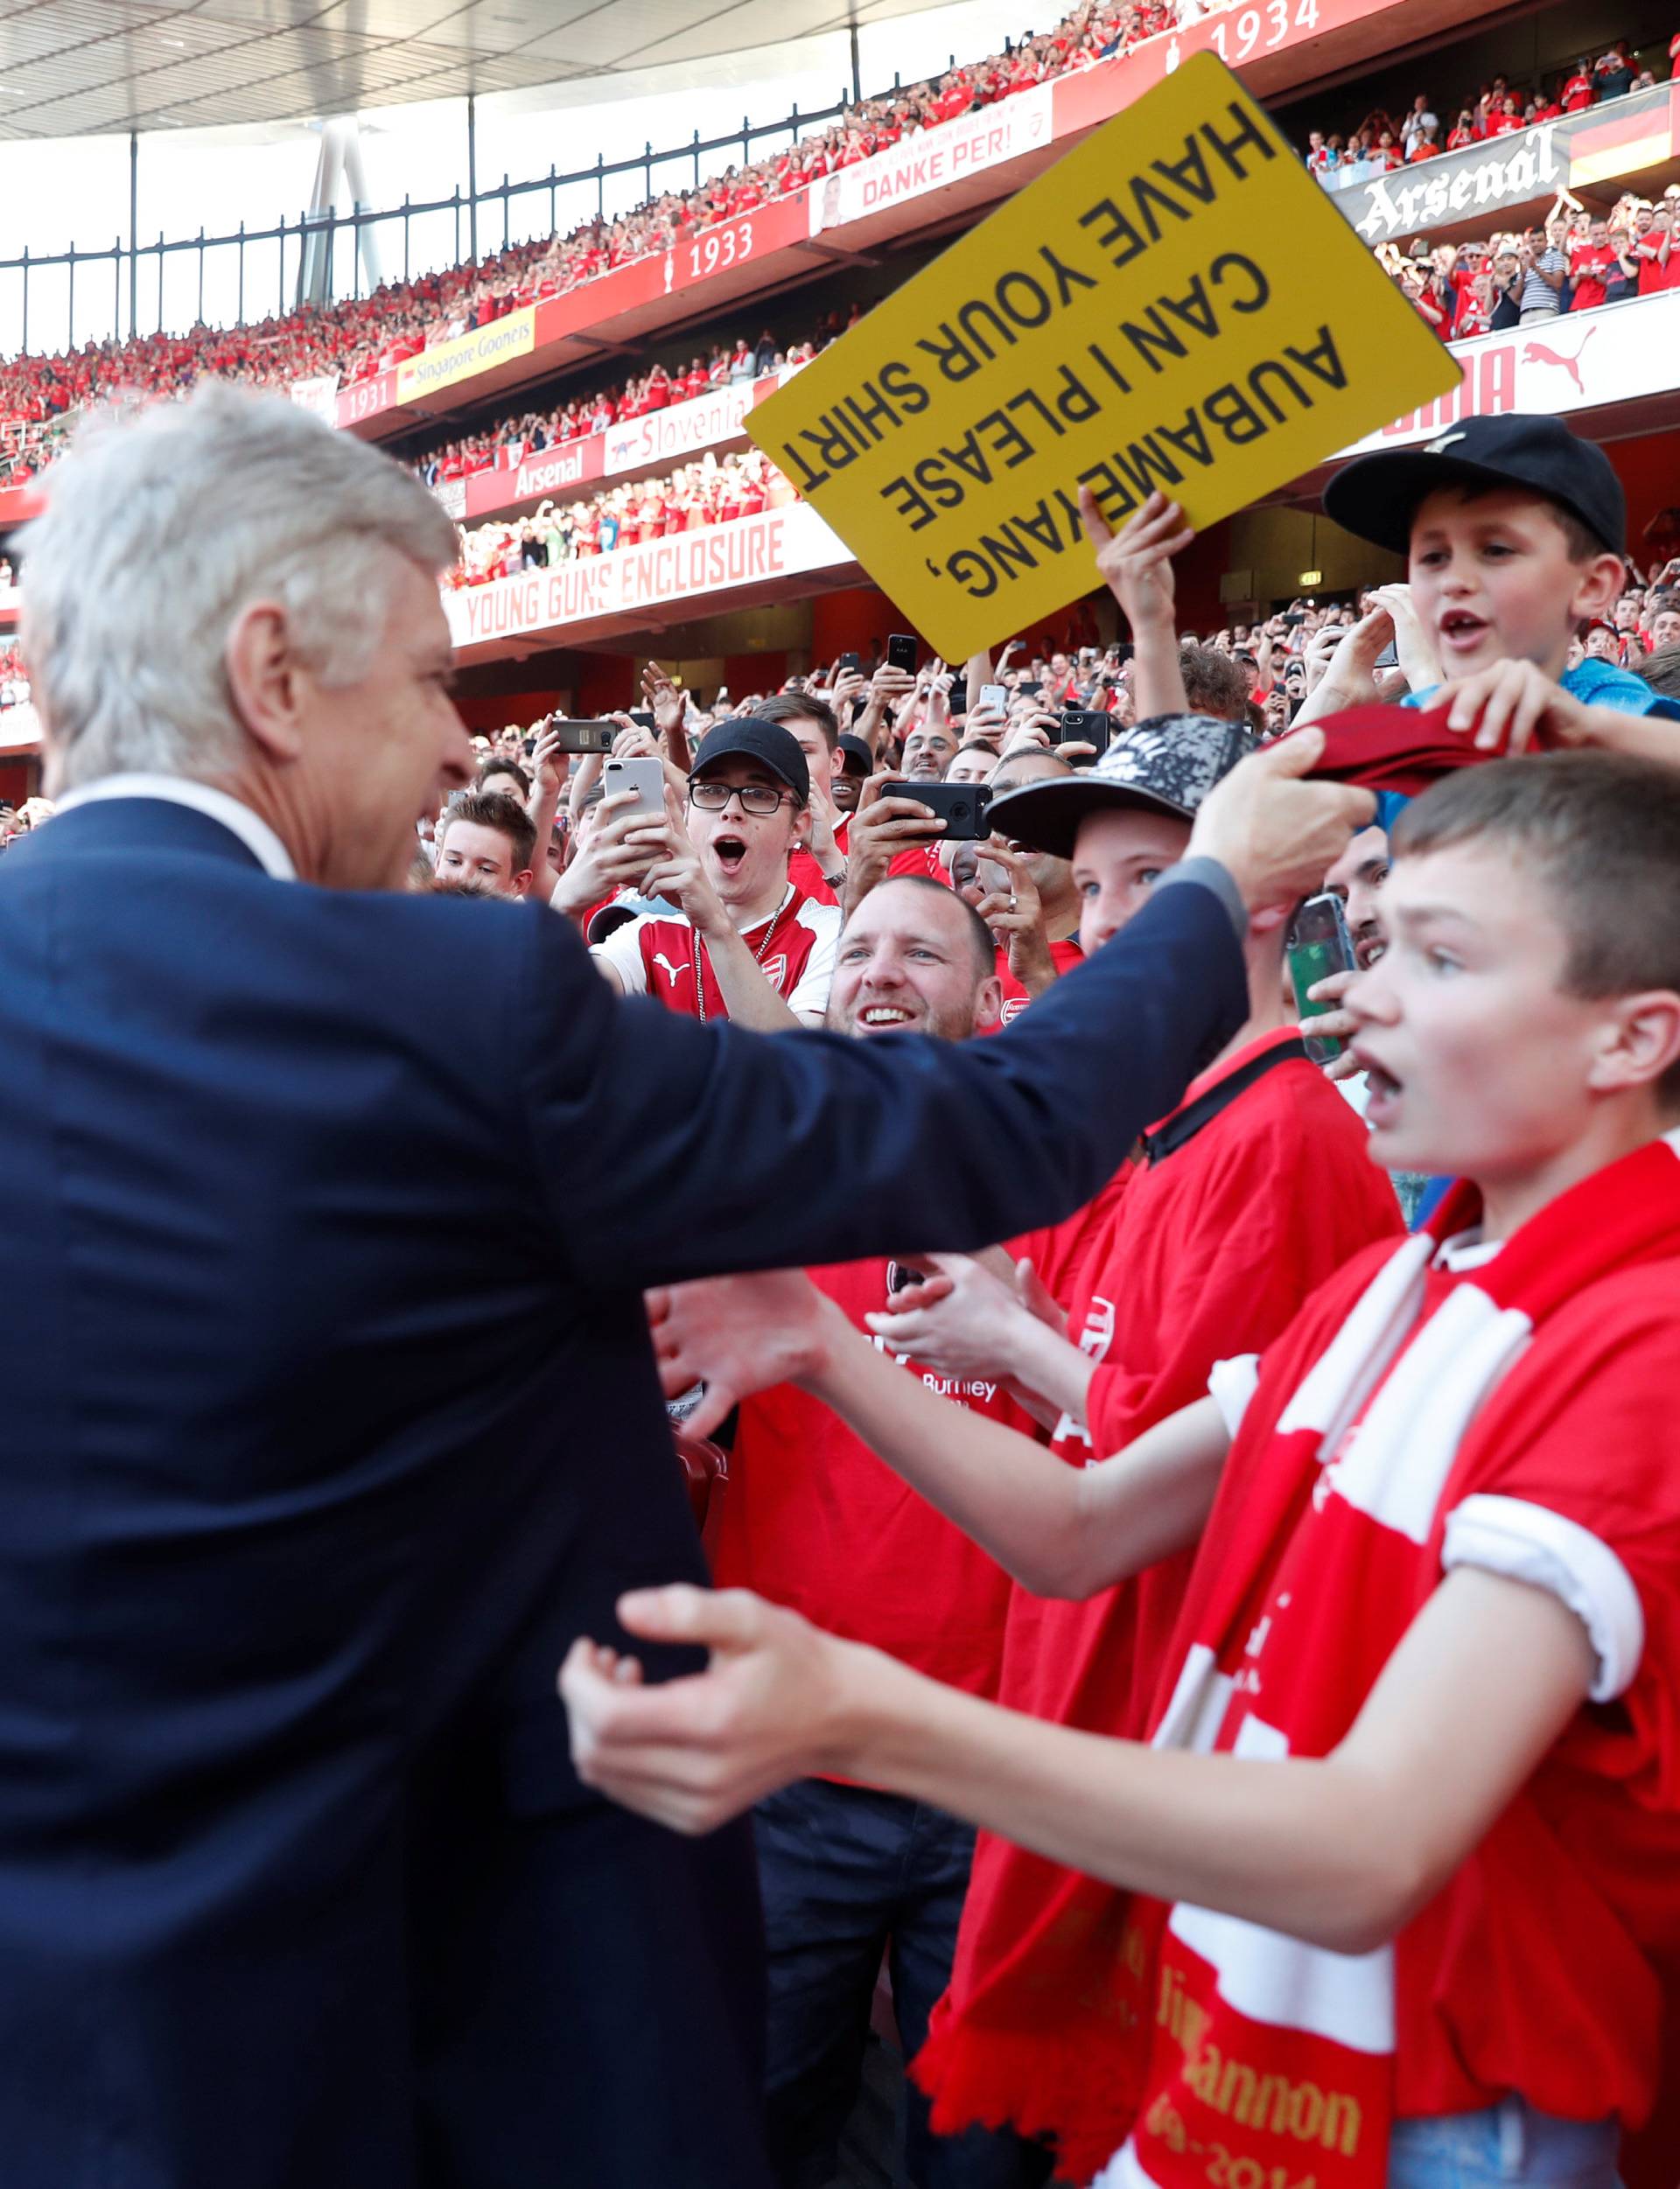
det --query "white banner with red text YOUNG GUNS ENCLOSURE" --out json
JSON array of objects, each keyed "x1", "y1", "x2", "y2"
[{"x1": 443, "y1": 501, "x2": 852, "y2": 648}]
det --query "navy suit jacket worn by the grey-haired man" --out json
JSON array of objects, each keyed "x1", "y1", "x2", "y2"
[{"x1": 0, "y1": 799, "x2": 1246, "y2": 2189}]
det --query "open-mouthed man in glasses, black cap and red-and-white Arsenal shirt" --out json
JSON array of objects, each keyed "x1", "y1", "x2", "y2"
[{"x1": 593, "y1": 716, "x2": 841, "y2": 1033}]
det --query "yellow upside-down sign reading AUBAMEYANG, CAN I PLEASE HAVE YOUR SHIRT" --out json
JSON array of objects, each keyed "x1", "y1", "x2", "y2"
[{"x1": 747, "y1": 52, "x2": 1459, "y2": 661}]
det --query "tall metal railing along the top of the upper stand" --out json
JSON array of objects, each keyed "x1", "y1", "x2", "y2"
[{"x1": 0, "y1": 55, "x2": 955, "y2": 354}]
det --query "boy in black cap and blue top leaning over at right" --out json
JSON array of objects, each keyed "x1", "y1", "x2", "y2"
[{"x1": 1297, "y1": 416, "x2": 1680, "y2": 759}]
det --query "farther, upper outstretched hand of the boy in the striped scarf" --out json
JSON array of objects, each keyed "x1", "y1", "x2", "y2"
[{"x1": 646, "y1": 1269, "x2": 828, "y2": 1436}]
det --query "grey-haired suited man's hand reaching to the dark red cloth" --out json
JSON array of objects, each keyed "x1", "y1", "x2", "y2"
[{"x1": 1185, "y1": 729, "x2": 1376, "y2": 913}]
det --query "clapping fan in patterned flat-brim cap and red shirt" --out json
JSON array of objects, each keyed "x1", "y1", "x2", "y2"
[{"x1": 870, "y1": 716, "x2": 1400, "y2": 2156}]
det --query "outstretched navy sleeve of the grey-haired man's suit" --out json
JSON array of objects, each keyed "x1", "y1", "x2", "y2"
[{"x1": 514, "y1": 886, "x2": 1249, "y2": 1287}]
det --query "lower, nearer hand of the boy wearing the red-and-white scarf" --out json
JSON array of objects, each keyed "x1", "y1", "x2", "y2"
[{"x1": 558, "y1": 1583, "x2": 852, "y2": 1835}]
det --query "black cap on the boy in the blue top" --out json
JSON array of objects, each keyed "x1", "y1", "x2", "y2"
[{"x1": 1325, "y1": 411, "x2": 1628, "y2": 554}]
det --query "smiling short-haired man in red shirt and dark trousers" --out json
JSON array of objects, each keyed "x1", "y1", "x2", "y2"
[{"x1": 712, "y1": 880, "x2": 1064, "y2": 2189}]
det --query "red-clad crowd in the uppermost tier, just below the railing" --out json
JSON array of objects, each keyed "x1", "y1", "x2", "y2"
[{"x1": 0, "y1": 0, "x2": 1179, "y2": 484}]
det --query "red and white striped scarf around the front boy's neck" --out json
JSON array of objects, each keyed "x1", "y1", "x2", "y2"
[{"x1": 1100, "y1": 1134, "x2": 1680, "y2": 2189}]
